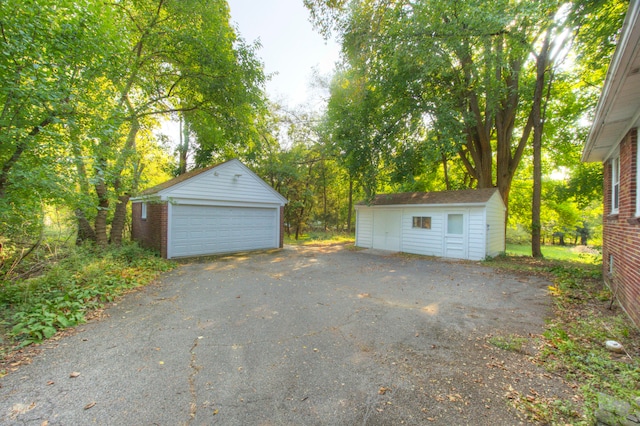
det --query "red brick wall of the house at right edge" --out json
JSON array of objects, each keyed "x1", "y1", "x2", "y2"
[{"x1": 602, "y1": 129, "x2": 640, "y2": 325}]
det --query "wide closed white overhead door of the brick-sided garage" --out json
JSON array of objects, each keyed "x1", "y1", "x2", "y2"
[{"x1": 169, "y1": 205, "x2": 279, "y2": 257}]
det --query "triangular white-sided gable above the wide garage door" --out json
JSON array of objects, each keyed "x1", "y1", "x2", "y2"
[{"x1": 158, "y1": 160, "x2": 283, "y2": 205}]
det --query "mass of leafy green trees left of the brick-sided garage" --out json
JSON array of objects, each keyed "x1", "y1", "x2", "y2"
[{"x1": 0, "y1": 0, "x2": 264, "y2": 255}]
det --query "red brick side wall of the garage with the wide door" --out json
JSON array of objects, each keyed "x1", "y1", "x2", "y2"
[{"x1": 131, "y1": 202, "x2": 168, "y2": 259}]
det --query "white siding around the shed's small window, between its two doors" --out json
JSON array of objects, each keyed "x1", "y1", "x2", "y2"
[{"x1": 402, "y1": 208, "x2": 444, "y2": 256}]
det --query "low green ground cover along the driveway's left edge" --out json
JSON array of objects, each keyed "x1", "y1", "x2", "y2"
[{"x1": 0, "y1": 244, "x2": 173, "y2": 346}]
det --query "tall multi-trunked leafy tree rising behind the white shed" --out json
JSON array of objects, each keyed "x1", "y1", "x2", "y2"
[{"x1": 307, "y1": 0, "x2": 560, "y2": 211}]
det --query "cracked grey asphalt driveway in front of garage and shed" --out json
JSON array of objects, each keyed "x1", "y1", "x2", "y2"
[{"x1": 0, "y1": 245, "x2": 571, "y2": 425}]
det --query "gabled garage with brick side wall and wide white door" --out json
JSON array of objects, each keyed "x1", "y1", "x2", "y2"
[{"x1": 131, "y1": 160, "x2": 287, "y2": 259}]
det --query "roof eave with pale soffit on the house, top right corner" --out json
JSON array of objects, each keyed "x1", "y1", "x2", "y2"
[{"x1": 582, "y1": 0, "x2": 640, "y2": 161}]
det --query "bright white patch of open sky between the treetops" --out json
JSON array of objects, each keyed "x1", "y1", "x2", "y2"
[{"x1": 228, "y1": 0, "x2": 340, "y2": 107}]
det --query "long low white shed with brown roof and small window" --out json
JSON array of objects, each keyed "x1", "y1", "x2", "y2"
[{"x1": 356, "y1": 188, "x2": 506, "y2": 260}]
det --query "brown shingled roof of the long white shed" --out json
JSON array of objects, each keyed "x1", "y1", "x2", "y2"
[{"x1": 358, "y1": 188, "x2": 498, "y2": 206}]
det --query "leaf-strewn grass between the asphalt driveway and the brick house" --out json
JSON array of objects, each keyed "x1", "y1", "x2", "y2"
[{"x1": 487, "y1": 246, "x2": 640, "y2": 425}]
